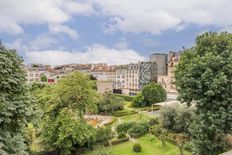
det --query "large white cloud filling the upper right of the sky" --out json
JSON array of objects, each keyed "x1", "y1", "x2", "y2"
[{"x1": 90, "y1": 0, "x2": 232, "y2": 34}]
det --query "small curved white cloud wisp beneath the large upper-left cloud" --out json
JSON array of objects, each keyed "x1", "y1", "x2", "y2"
[{"x1": 49, "y1": 24, "x2": 78, "y2": 39}]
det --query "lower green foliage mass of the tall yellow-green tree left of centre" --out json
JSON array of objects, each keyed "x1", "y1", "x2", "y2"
[{"x1": 42, "y1": 108, "x2": 94, "y2": 154}]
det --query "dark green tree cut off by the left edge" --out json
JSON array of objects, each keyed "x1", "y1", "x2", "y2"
[{"x1": 0, "y1": 44, "x2": 36, "y2": 155}]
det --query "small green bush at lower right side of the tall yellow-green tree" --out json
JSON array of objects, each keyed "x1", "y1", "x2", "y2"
[{"x1": 95, "y1": 127, "x2": 113, "y2": 144}]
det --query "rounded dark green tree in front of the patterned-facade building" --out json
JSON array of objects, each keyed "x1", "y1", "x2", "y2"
[{"x1": 142, "y1": 83, "x2": 167, "y2": 105}]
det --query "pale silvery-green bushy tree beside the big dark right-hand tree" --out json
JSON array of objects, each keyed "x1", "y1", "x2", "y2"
[{"x1": 159, "y1": 104, "x2": 195, "y2": 133}]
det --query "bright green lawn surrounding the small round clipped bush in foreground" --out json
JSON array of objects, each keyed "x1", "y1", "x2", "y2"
[{"x1": 83, "y1": 134, "x2": 191, "y2": 155}]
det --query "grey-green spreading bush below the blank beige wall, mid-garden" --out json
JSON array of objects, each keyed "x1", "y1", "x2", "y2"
[{"x1": 98, "y1": 93, "x2": 124, "y2": 112}]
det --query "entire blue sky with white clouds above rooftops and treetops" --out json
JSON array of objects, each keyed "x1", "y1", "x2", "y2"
[{"x1": 0, "y1": 0, "x2": 232, "y2": 66}]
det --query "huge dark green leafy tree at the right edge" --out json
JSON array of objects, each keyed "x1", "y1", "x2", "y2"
[{"x1": 175, "y1": 32, "x2": 232, "y2": 155}]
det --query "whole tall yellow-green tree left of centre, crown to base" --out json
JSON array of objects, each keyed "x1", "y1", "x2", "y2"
[{"x1": 42, "y1": 72, "x2": 98, "y2": 154}]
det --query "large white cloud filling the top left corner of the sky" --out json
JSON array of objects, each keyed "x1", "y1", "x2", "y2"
[{"x1": 0, "y1": 0, "x2": 94, "y2": 37}]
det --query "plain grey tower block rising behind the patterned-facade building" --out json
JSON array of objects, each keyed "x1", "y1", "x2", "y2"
[{"x1": 149, "y1": 53, "x2": 167, "y2": 75}]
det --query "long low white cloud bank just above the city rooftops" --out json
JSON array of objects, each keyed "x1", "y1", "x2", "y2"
[{"x1": 26, "y1": 45, "x2": 145, "y2": 65}]
